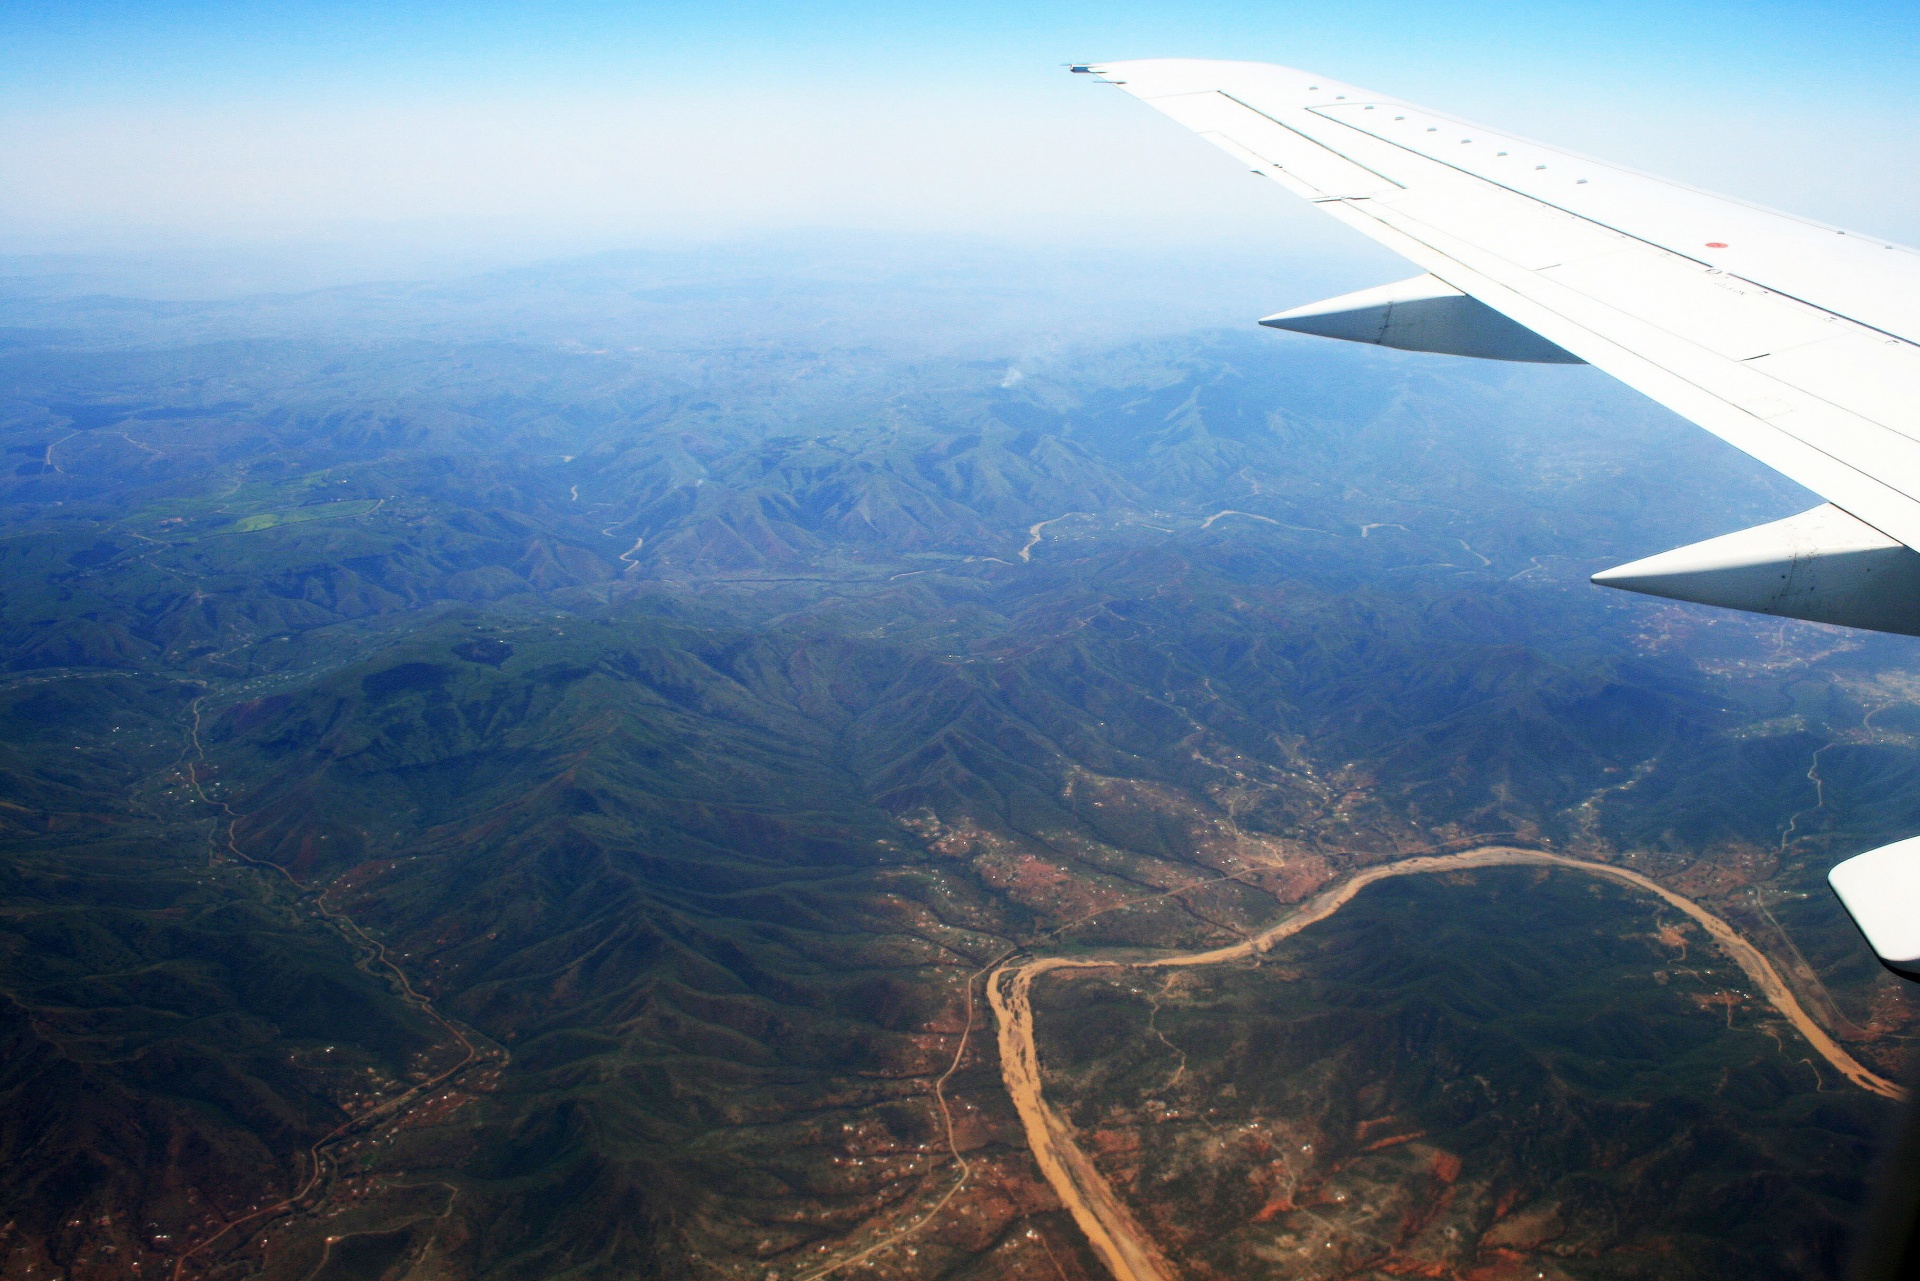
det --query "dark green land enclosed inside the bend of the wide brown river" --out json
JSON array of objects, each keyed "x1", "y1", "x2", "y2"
[{"x1": 1035, "y1": 870, "x2": 1895, "y2": 1279}]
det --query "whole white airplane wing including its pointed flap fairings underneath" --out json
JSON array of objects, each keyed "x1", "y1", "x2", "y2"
[{"x1": 1073, "y1": 60, "x2": 1920, "y2": 979}]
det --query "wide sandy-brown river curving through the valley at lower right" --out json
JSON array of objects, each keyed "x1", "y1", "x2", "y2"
[{"x1": 987, "y1": 845, "x2": 1903, "y2": 1281}]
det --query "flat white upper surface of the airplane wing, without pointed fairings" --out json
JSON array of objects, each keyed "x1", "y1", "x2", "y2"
[{"x1": 1075, "y1": 60, "x2": 1920, "y2": 556}]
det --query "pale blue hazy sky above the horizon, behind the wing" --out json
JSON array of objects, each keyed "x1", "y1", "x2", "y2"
[{"x1": 0, "y1": 0, "x2": 1920, "y2": 272}]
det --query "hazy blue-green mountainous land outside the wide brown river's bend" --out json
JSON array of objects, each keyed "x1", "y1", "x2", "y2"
[{"x1": 0, "y1": 242, "x2": 1920, "y2": 1281}]
